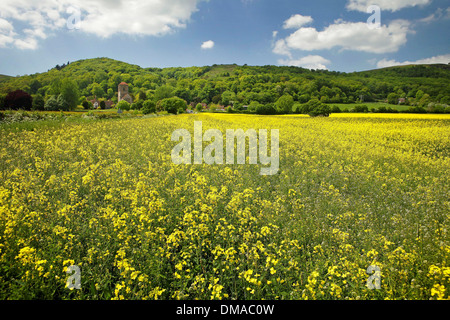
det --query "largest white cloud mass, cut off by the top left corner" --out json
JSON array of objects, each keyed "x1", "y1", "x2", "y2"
[{"x1": 0, "y1": 0, "x2": 205, "y2": 49}]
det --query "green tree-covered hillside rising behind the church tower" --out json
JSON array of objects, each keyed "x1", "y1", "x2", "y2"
[{"x1": 0, "y1": 58, "x2": 450, "y2": 114}]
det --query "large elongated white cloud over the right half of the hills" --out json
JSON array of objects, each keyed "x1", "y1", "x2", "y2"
[{"x1": 273, "y1": 20, "x2": 412, "y2": 56}]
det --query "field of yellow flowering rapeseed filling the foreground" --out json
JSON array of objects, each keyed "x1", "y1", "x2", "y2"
[{"x1": 0, "y1": 114, "x2": 450, "y2": 300}]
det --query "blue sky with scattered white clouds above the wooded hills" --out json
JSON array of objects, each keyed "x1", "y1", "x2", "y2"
[{"x1": 0, "y1": 0, "x2": 450, "y2": 76}]
